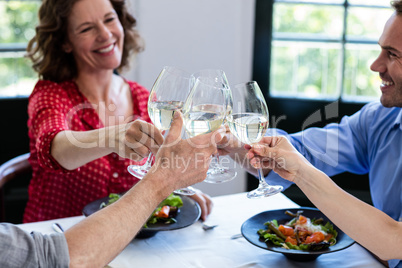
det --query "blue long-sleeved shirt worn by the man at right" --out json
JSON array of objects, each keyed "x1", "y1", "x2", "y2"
[{"x1": 267, "y1": 102, "x2": 402, "y2": 267}]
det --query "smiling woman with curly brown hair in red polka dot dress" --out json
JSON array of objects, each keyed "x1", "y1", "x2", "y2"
[{"x1": 24, "y1": 0, "x2": 212, "y2": 222}]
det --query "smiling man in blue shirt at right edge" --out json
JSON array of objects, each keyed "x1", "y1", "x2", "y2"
[{"x1": 221, "y1": 0, "x2": 402, "y2": 267}]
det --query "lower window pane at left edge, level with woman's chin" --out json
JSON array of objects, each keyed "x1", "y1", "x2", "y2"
[{"x1": 0, "y1": 52, "x2": 38, "y2": 97}]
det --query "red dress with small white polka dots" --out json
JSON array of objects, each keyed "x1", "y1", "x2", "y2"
[{"x1": 24, "y1": 80, "x2": 151, "y2": 222}]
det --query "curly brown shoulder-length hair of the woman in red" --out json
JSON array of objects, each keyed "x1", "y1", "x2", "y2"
[{"x1": 26, "y1": 0, "x2": 144, "y2": 82}]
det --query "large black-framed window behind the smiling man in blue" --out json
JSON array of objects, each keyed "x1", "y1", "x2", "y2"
[{"x1": 260, "y1": 0, "x2": 393, "y2": 102}]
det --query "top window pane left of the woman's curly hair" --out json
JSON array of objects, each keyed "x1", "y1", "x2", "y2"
[{"x1": 0, "y1": 1, "x2": 41, "y2": 44}]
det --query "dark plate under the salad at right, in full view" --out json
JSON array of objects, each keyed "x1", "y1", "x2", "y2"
[{"x1": 241, "y1": 207, "x2": 355, "y2": 261}]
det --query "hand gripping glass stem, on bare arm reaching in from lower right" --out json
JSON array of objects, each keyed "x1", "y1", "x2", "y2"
[{"x1": 247, "y1": 136, "x2": 311, "y2": 181}]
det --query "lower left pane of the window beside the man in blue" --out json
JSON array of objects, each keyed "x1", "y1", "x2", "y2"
[{"x1": 270, "y1": 41, "x2": 341, "y2": 98}]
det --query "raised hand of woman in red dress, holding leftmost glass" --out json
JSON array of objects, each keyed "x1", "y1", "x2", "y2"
[{"x1": 114, "y1": 120, "x2": 164, "y2": 161}]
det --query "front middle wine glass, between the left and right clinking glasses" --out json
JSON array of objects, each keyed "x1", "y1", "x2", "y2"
[{"x1": 183, "y1": 77, "x2": 236, "y2": 183}]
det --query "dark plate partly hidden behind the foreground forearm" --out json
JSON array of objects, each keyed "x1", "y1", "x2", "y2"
[{"x1": 82, "y1": 193, "x2": 201, "y2": 238}]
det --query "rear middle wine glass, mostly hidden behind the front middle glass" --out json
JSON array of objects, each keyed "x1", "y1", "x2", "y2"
[{"x1": 193, "y1": 69, "x2": 237, "y2": 183}]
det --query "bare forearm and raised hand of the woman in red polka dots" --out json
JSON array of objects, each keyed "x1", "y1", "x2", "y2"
[{"x1": 51, "y1": 120, "x2": 163, "y2": 170}]
